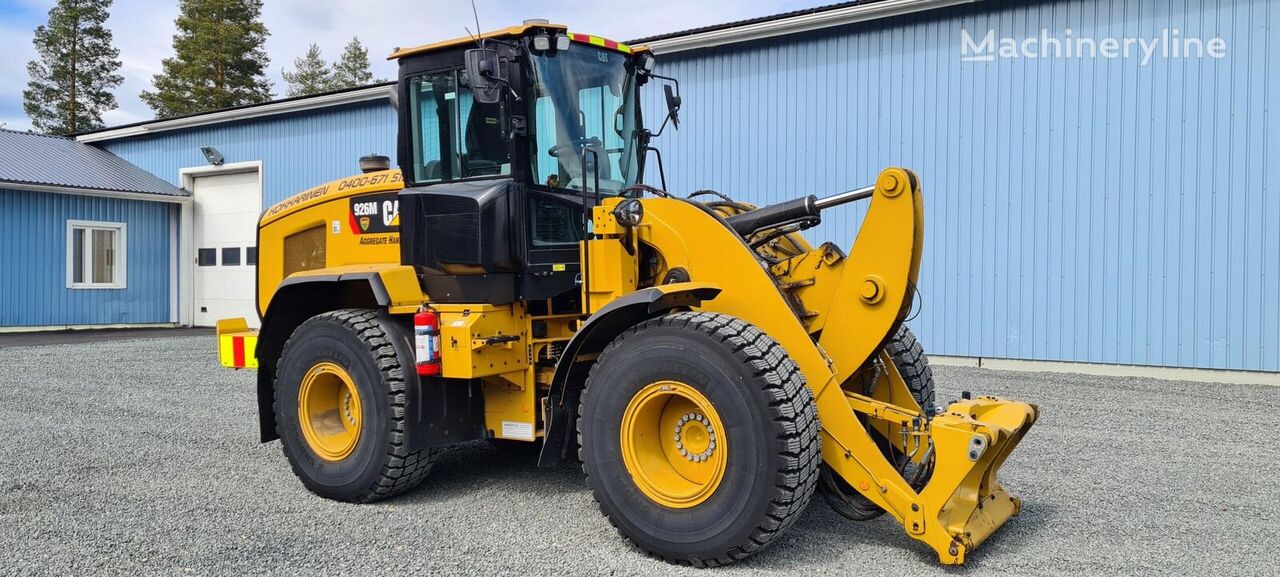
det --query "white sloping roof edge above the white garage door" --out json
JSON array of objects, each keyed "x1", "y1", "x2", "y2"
[{"x1": 76, "y1": 86, "x2": 394, "y2": 142}]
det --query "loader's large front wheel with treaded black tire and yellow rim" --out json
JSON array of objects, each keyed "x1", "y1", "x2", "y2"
[{"x1": 577, "y1": 312, "x2": 822, "y2": 567}]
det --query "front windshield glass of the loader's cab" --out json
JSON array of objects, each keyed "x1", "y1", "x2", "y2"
[{"x1": 529, "y1": 42, "x2": 639, "y2": 194}]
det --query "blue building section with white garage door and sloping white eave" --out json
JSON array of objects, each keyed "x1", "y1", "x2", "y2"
[{"x1": 78, "y1": 84, "x2": 396, "y2": 326}]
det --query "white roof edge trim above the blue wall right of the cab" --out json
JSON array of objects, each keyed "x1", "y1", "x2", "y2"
[{"x1": 645, "y1": 0, "x2": 980, "y2": 54}]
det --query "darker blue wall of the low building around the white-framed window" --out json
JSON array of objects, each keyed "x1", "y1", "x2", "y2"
[{"x1": 0, "y1": 188, "x2": 173, "y2": 326}]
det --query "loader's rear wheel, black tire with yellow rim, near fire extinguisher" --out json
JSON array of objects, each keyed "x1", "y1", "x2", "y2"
[{"x1": 275, "y1": 308, "x2": 436, "y2": 503}]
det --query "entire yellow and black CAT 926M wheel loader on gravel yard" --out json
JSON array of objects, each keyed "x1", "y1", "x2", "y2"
[{"x1": 219, "y1": 22, "x2": 1037, "y2": 565}]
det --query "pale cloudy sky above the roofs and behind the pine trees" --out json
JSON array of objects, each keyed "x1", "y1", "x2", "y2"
[{"x1": 0, "y1": 0, "x2": 835, "y2": 129}]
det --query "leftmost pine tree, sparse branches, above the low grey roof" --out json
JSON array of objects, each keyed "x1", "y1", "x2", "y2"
[{"x1": 22, "y1": 0, "x2": 124, "y2": 134}]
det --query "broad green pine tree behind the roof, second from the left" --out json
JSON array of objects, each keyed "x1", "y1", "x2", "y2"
[{"x1": 141, "y1": 0, "x2": 271, "y2": 118}]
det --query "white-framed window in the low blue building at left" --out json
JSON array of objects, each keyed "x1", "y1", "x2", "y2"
[{"x1": 67, "y1": 220, "x2": 125, "y2": 289}]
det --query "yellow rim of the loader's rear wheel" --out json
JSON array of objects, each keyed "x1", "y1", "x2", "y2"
[{"x1": 298, "y1": 361, "x2": 364, "y2": 461}]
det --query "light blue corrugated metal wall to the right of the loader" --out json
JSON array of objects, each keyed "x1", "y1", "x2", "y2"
[{"x1": 645, "y1": 0, "x2": 1280, "y2": 371}]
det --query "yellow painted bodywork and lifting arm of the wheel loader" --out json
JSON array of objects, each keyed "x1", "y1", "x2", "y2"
[{"x1": 220, "y1": 169, "x2": 1037, "y2": 564}]
